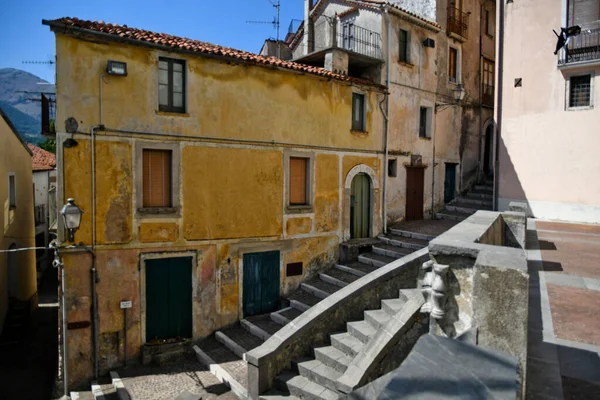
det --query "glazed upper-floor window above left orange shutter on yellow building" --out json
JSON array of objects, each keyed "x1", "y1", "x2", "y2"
[{"x1": 158, "y1": 57, "x2": 185, "y2": 113}]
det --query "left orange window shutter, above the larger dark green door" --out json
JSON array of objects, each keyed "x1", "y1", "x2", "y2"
[{"x1": 143, "y1": 149, "x2": 171, "y2": 207}]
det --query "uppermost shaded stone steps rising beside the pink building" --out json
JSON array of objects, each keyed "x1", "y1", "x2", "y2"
[{"x1": 435, "y1": 179, "x2": 494, "y2": 221}]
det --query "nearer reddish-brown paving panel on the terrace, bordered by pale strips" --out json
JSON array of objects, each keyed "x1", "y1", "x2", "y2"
[{"x1": 547, "y1": 284, "x2": 600, "y2": 346}]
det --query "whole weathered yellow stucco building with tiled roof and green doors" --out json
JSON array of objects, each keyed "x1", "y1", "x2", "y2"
[{"x1": 44, "y1": 18, "x2": 385, "y2": 383}]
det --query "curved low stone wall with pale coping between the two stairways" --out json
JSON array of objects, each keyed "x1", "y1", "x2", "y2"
[{"x1": 246, "y1": 248, "x2": 429, "y2": 399}]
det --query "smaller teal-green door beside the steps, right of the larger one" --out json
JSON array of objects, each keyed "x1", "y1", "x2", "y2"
[{"x1": 243, "y1": 251, "x2": 279, "y2": 316}]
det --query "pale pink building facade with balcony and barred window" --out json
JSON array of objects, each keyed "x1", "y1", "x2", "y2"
[{"x1": 495, "y1": 0, "x2": 600, "y2": 223}]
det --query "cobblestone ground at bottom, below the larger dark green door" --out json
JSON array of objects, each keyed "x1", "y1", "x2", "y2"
[{"x1": 118, "y1": 354, "x2": 238, "y2": 400}]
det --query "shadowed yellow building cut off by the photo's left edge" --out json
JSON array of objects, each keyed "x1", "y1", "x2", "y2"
[{"x1": 0, "y1": 109, "x2": 37, "y2": 333}]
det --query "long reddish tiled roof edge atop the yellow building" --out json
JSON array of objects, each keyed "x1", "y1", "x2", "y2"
[{"x1": 42, "y1": 17, "x2": 383, "y2": 88}]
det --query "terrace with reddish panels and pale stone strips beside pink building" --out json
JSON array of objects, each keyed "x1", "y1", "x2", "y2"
[{"x1": 527, "y1": 220, "x2": 600, "y2": 399}]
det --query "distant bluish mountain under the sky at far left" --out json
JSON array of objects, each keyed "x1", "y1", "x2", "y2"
[{"x1": 0, "y1": 68, "x2": 56, "y2": 143}]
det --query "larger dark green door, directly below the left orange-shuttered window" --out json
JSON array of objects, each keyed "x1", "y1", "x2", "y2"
[{"x1": 146, "y1": 257, "x2": 192, "y2": 342}]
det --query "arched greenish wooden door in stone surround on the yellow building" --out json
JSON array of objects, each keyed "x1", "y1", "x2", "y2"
[{"x1": 350, "y1": 174, "x2": 371, "y2": 239}]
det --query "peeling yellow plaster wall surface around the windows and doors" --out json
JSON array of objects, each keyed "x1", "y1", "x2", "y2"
[{"x1": 55, "y1": 34, "x2": 383, "y2": 384}]
